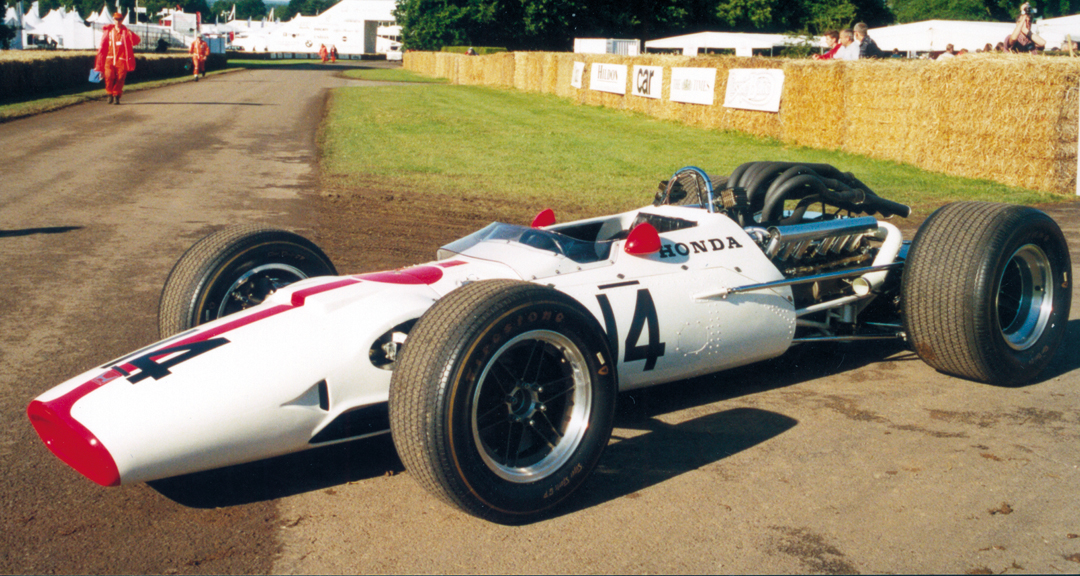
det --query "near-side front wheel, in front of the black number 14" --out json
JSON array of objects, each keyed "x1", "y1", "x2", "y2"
[{"x1": 390, "y1": 280, "x2": 617, "y2": 524}]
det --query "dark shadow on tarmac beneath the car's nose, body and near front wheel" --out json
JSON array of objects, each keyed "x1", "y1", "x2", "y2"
[{"x1": 150, "y1": 343, "x2": 915, "y2": 513}]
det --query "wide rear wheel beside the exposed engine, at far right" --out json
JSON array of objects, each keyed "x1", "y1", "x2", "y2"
[{"x1": 902, "y1": 202, "x2": 1072, "y2": 386}]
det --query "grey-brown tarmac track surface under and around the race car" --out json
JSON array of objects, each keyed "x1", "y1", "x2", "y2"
[{"x1": 0, "y1": 65, "x2": 1080, "y2": 574}]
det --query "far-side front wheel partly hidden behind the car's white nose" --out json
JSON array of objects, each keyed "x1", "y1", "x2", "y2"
[{"x1": 158, "y1": 225, "x2": 337, "y2": 338}]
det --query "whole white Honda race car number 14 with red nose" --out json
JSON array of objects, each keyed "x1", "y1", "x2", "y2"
[{"x1": 27, "y1": 162, "x2": 1071, "y2": 523}]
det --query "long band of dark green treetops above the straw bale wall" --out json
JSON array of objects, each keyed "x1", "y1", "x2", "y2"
[{"x1": 393, "y1": 0, "x2": 898, "y2": 50}]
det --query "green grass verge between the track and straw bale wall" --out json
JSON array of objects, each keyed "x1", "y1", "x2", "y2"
[{"x1": 321, "y1": 85, "x2": 1068, "y2": 216}]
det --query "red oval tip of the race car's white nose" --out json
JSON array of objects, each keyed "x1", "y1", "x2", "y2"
[{"x1": 26, "y1": 400, "x2": 120, "y2": 486}]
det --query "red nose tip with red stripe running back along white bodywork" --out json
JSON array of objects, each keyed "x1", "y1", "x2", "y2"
[{"x1": 26, "y1": 278, "x2": 360, "y2": 486}]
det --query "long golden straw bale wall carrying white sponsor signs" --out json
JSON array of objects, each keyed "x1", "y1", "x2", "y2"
[{"x1": 405, "y1": 52, "x2": 1080, "y2": 195}]
